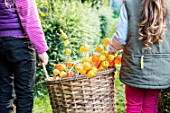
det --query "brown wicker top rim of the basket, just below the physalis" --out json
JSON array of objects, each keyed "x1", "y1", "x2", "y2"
[{"x1": 45, "y1": 67, "x2": 116, "y2": 84}]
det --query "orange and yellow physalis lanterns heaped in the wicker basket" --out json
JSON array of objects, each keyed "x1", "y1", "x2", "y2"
[{"x1": 53, "y1": 30, "x2": 121, "y2": 79}]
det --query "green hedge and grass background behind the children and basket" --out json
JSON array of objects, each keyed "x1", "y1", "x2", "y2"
[{"x1": 28, "y1": 0, "x2": 170, "y2": 113}]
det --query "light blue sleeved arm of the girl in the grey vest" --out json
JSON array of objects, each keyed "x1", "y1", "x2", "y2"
[{"x1": 108, "y1": 4, "x2": 128, "y2": 52}]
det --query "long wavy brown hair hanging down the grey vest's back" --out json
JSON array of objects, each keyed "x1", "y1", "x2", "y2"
[{"x1": 138, "y1": 0, "x2": 168, "y2": 47}]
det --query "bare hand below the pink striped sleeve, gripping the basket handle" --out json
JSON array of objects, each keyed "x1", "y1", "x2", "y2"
[{"x1": 38, "y1": 52, "x2": 48, "y2": 66}]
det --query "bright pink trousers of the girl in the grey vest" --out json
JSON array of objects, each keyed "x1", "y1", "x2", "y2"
[{"x1": 125, "y1": 85, "x2": 160, "y2": 113}]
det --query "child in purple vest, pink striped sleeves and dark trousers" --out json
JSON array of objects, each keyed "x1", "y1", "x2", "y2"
[{"x1": 0, "y1": 0, "x2": 48, "y2": 113}]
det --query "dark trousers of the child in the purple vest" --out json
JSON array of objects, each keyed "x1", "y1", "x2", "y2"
[{"x1": 0, "y1": 37, "x2": 36, "y2": 113}]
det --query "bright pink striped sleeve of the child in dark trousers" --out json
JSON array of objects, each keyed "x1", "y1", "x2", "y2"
[{"x1": 16, "y1": 0, "x2": 48, "y2": 54}]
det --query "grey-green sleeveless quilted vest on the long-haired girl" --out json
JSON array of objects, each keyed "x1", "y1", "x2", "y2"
[{"x1": 120, "y1": 0, "x2": 170, "y2": 89}]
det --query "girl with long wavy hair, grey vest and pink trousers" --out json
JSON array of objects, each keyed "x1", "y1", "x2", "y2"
[{"x1": 108, "y1": 0, "x2": 170, "y2": 113}]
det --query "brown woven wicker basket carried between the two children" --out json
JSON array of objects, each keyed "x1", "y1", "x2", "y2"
[{"x1": 46, "y1": 69, "x2": 116, "y2": 113}]
